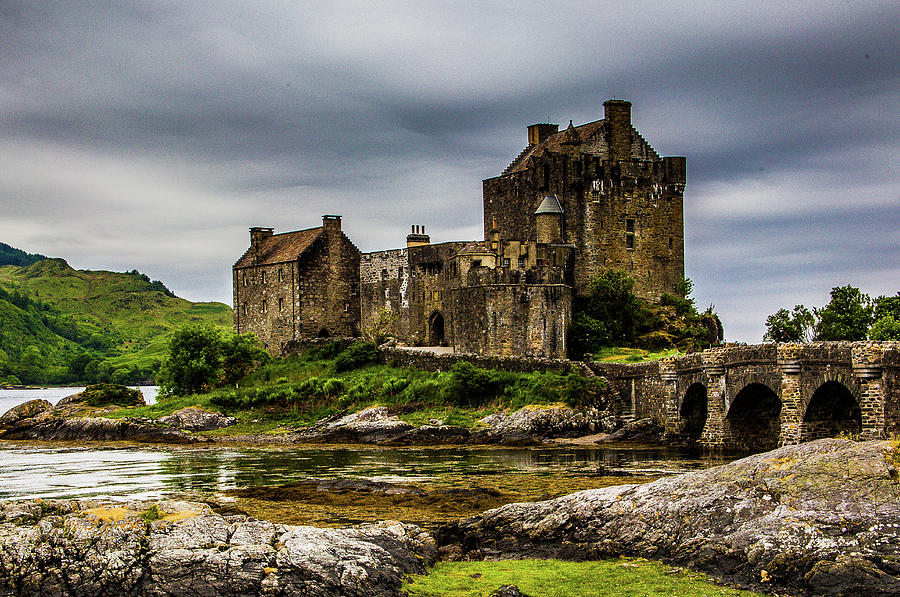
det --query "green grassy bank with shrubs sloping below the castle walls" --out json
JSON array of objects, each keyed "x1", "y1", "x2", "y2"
[{"x1": 107, "y1": 345, "x2": 608, "y2": 435}]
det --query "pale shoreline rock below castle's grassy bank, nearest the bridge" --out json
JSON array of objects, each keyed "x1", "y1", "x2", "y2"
[{"x1": 469, "y1": 405, "x2": 615, "y2": 445}]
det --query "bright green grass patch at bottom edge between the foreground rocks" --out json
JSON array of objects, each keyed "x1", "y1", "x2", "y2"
[{"x1": 403, "y1": 558, "x2": 761, "y2": 597}]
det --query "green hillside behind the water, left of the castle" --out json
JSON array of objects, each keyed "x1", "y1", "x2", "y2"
[{"x1": 0, "y1": 259, "x2": 232, "y2": 383}]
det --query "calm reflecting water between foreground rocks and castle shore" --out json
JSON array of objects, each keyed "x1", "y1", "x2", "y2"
[{"x1": 0, "y1": 442, "x2": 725, "y2": 499}]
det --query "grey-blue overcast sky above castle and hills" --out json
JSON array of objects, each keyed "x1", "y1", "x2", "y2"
[{"x1": 0, "y1": 0, "x2": 900, "y2": 342}]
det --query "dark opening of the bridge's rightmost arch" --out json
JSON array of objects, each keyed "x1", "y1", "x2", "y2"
[{"x1": 800, "y1": 381, "x2": 862, "y2": 442}]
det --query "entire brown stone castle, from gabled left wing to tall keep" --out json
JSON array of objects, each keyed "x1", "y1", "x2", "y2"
[{"x1": 233, "y1": 100, "x2": 685, "y2": 358}]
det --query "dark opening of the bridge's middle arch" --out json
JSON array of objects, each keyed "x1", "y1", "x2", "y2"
[{"x1": 725, "y1": 383, "x2": 781, "y2": 452}]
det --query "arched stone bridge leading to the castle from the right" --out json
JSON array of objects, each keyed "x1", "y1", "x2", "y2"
[{"x1": 591, "y1": 342, "x2": 900, "y2": 451}]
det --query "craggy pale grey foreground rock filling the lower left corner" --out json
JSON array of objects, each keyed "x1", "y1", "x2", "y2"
[{"x1": 0, "y1": 502, "x2": 437, "y2": 597}]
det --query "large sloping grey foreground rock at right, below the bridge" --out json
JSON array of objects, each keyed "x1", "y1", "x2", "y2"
[{"x1": 438, "y1": 439, "x2": 900, "y2": 596}]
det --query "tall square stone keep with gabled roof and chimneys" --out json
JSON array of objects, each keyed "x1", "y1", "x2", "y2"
[{"x1": 483, "y1": 100, "x2": 685, "y2": 301}]
